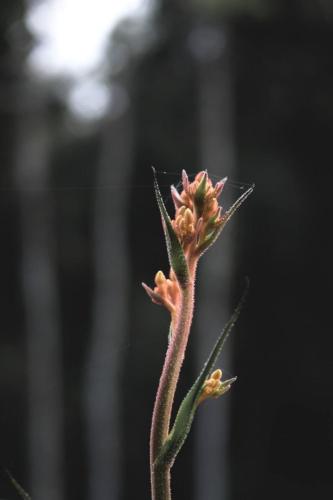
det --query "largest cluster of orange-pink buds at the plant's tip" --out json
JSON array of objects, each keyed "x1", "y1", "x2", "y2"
[{"x1": 171, "y1": 170, "x2": 227, "y2": 256}]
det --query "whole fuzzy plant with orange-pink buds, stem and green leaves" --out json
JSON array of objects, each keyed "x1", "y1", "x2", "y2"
[{"x1": 142, "y1": 171, "x2": 253, "y2": 500}]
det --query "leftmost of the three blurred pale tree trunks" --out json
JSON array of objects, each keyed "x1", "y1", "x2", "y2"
[{"x1": 15, "y1": 82, "x2": 64, "y2": 500}]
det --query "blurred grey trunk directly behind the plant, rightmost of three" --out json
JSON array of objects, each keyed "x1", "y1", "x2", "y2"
[{"x1": 194, "y1": 27, "x2": 234, "y2": 500}]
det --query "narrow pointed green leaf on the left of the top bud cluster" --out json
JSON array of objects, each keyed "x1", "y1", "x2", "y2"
[{"x1": 152, "y1": 167, "x2": 189, "y2": 289}]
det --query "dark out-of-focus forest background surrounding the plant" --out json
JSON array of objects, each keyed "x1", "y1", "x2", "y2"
[{"x1": 0, "y1": 0, "x2": 333, "y2": 500}]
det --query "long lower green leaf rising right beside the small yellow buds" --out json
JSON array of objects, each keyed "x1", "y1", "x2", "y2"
[{"x1": 155, "y1": 281, "x2": 249, "y2": 467}]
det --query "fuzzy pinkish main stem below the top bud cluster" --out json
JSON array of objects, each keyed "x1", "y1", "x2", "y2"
[{"x1": 150, "y1": 260, "x2": 197, "y2": 500}]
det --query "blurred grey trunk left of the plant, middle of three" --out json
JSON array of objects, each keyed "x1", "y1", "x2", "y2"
[{"x1": 85, "y1": 105, "x2": 132, "y2": 500}]
